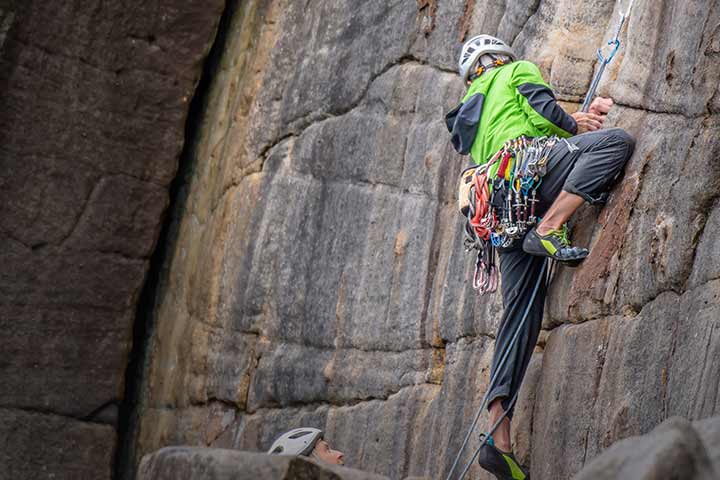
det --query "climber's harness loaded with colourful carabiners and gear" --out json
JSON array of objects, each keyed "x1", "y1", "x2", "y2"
[{"x1": 458, "y1": 136, "x2": 558, "y2": 295}]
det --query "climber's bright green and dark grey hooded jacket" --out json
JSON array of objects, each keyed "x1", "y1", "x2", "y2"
[{"x1": 445, "y1": 60, "x2": 577, "y2": 176}]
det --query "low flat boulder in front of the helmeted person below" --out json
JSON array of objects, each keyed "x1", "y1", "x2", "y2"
[{"x1": 138, "y1": 447, "x2": 387, "y2": 480}]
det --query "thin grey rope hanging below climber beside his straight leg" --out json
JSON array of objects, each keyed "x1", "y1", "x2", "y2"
[{"x1": 445, "y1": 259, "x2": 551, "y2": 480}]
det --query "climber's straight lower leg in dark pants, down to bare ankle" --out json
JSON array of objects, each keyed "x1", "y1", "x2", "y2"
[{"x1": 488, "y1": 245, "x2": 546, "y2": 451}]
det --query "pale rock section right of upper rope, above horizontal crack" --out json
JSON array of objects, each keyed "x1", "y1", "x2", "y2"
[{"x1": 600, "y1": 1, "x2": 720, "y2": 117}]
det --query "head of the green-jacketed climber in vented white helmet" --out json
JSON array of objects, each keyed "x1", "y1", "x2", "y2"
[{"x1": 458, "y1": 35, "x2": 517, "y2": 86}]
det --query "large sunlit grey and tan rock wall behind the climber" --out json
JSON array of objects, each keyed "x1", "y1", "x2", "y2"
[{"x1": 124, "y1": 0, "x2": 720, "y2": 479}]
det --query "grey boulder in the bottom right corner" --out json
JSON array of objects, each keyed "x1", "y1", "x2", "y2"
[{"x1": 574, "y1": 417, "x2": 720, "y2": 480}]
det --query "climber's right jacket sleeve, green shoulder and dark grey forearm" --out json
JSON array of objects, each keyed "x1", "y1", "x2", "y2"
[{"x1": 512, "y1": 61, "x2": 577, "y2": 137}]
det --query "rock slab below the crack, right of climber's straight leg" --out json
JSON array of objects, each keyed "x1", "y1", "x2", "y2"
[{"x1": 531, "y1": 281, "x2": 720, "y2": 478}]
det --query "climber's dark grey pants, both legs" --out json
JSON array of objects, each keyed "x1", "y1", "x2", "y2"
[{"x1": 487, "y1": 128, "x2": 635, "y2": 418}]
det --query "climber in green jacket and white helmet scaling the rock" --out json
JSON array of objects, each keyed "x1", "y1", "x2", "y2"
[{"x1": 446, "y1": 35, "x2": 635, "y2": 480}]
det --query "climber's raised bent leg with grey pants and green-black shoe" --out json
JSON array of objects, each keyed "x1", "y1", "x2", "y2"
[{"x1": 523, "y1": 128, "x2": 635, "y2": 265}]
